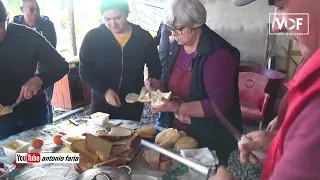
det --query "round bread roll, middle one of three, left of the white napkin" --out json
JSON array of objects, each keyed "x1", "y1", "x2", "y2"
[{"x1": 155, "y1": 128, "x2": 180, "y2": 148}]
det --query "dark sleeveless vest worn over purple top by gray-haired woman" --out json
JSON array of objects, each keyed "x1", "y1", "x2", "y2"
[{"x1": 164, "y1": 25, "x2": 243, "y2": 156}]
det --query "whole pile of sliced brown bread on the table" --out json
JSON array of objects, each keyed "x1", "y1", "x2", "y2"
[{"x1": 70, "y1": 129, "x2": 141, "y2": 173}]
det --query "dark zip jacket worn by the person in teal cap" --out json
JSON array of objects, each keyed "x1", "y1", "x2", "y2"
[{"x1": 80, "y1": 24, "x2": 161, "y2": 107}]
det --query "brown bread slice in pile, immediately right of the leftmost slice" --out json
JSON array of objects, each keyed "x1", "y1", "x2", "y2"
[{"x1": 86, "y1": 134, "x2": 113, "y2": 161}]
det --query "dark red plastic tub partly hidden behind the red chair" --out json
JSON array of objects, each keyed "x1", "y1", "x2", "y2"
[{"x1": 239, "y1": 65, "x2": 286, "y2": 124}]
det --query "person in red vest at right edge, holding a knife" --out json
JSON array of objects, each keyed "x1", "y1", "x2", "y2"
[{"x1": 210, "y1": 0, "x2": 320, "y2": 180}]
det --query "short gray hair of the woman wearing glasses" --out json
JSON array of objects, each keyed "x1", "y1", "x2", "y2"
[{"x1": 164, "y1": 0, "x2": 207, "y2": 28}]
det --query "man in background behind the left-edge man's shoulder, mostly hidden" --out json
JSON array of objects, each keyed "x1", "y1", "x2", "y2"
[{"x1": 13, "y1": 0, "x2": 57, "y2": 119}]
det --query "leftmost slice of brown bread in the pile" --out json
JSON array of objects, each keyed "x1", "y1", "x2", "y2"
[{"x1": 70, "y1": 139, "x2": 99, "y2": 164}]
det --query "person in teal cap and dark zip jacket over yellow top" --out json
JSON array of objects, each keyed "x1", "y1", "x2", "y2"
[{"x1": 80, "y1": 0, "x2": 161, "y2": 121}]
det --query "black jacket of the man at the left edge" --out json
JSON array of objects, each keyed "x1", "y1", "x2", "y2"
[{"x1": 0, "y1": 23, "x2": 69, "y2": 116}]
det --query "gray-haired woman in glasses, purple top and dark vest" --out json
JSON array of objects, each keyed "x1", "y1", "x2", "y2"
[{"x1": 146, "y1": 0, "x2": 242, "y2": 165}]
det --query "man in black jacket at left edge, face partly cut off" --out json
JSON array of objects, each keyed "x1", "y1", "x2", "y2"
[{"x1": 0, "y1": 0, "x2": 69, "y2": 139}]
